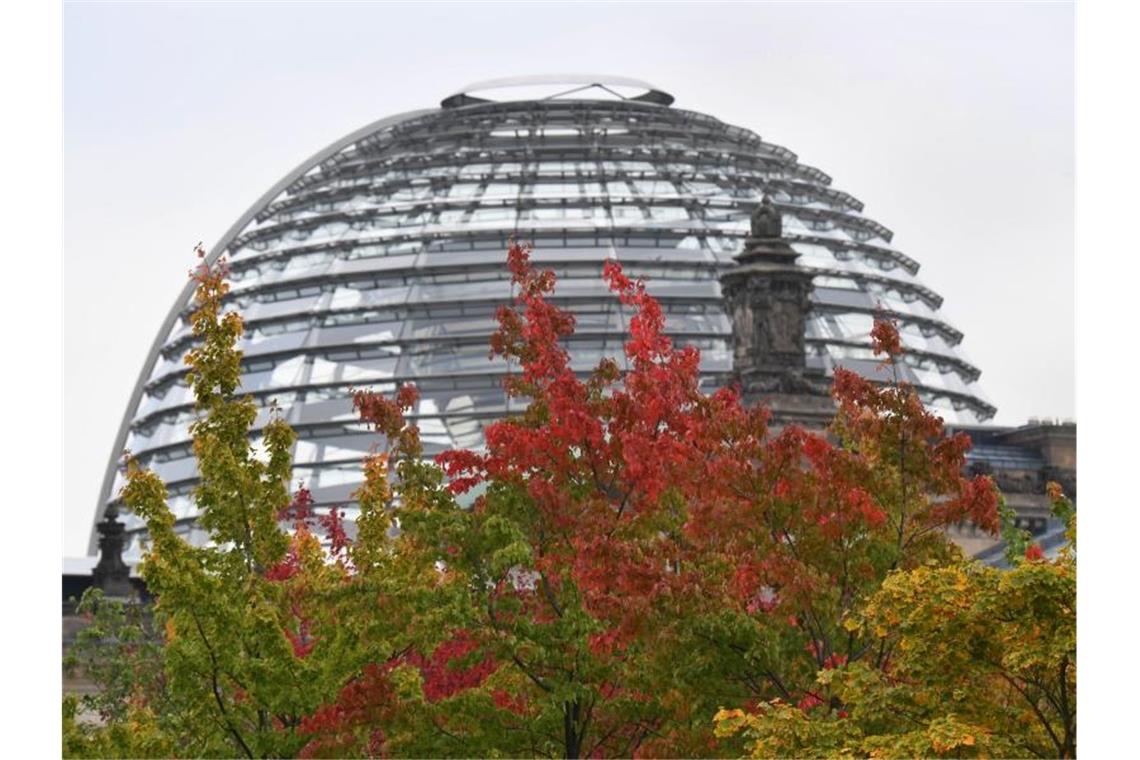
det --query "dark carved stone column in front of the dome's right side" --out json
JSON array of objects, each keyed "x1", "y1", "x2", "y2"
[{"x1": 720, "y1": 196, "x2": 834, "y2": 427}]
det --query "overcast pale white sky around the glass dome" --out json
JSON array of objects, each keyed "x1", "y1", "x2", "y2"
[{"x1": 64, "y1": 2, "x2": 1076, "y2": 555}]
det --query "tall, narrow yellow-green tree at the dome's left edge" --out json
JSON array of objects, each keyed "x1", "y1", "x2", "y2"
[{"x1": 72, "y1": 247, "x2": 371, "y2": 758}]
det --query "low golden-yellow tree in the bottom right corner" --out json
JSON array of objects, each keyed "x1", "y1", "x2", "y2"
[{"x1": 717, "y1": 484, "x2": 1076, "y2": 758}]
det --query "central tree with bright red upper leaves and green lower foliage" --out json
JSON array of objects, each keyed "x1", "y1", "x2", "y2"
[{"x1": 296, "y1": 245, "x2": 998, "y2": 757}]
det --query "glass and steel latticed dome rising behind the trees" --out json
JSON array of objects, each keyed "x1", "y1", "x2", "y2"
[{"x1": 96, "y1": 76, "x2": 994, "y2": 553}]
